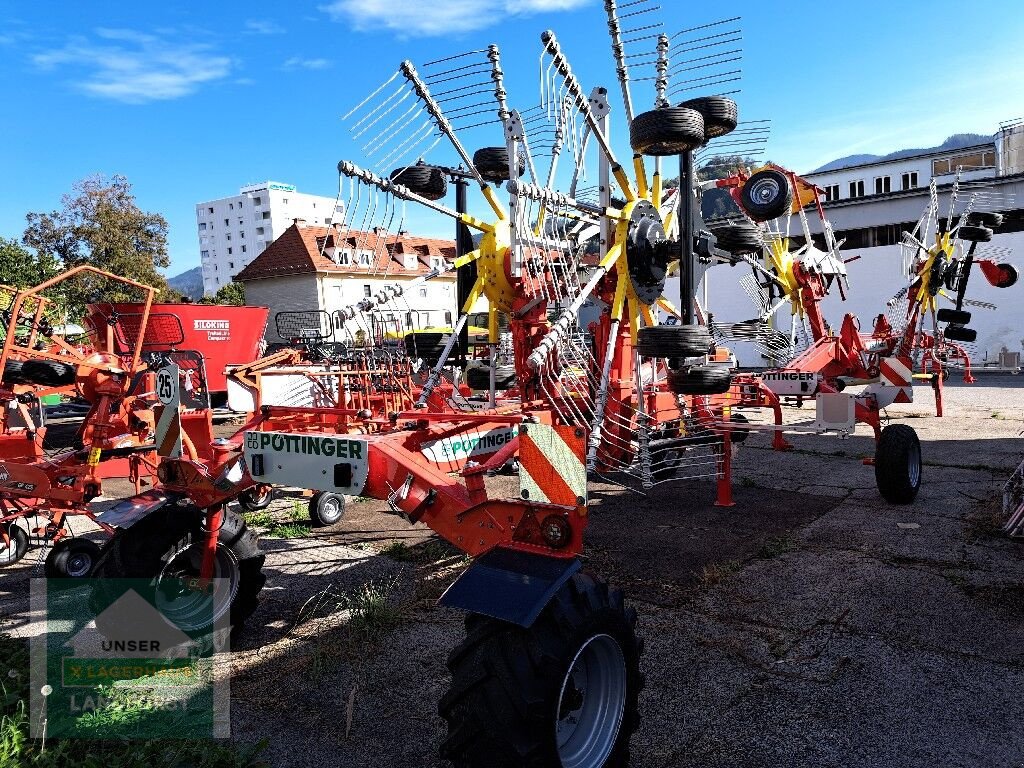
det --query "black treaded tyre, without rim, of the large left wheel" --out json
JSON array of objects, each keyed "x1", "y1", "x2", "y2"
[{"x1": 91, "y1": 512, "x2": 266, "y2": 634}]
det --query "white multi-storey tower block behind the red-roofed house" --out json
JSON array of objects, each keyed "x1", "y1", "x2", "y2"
[{"x1": 196, "y1": 181, "x2": 344, "y2": 296}]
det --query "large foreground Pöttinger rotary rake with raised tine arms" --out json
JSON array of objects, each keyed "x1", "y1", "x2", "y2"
[{"x1": 70, "y1": 0, "x2": 937, "y2": 768}]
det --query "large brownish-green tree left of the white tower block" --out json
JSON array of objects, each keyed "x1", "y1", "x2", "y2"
[{"x1": 23, "y1": 175, "x2": 170, "y2": 316}]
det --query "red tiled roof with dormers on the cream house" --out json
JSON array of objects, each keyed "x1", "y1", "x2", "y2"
[{"x1": 234, "y1": 224, "x2": 455, "y2": 283}]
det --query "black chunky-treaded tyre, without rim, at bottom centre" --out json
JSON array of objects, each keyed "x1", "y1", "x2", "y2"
[{"x1": 437, "y1": 572, "x2": 644, "y2": 768}]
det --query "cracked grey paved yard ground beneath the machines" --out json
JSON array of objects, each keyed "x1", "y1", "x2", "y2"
[{"x1": 0, "y1": 376, "x2": 1024, "y2": 768}]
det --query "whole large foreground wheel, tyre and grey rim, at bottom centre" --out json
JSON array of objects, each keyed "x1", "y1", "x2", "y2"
[{"x1": 438, "y1": 572, "x2": 644, "y2": 768}]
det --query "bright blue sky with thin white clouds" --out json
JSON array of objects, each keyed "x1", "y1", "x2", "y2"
[{"x1": 0, "y1": 0, "x2": 1024, "y2": 274}]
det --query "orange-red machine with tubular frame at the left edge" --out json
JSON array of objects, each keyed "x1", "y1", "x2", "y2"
[{"x1": 0, "y1": 266, "x2": 210, "y2": 578}]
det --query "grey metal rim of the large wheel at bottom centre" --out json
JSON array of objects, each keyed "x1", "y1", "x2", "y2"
[{"x1": 555, "y1": 635, "x2": 627, "y2": 768}]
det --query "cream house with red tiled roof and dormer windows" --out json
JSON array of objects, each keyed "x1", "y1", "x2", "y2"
[{"x1": 234, "y1": 219, "x2": 458, "y2": 344}]
